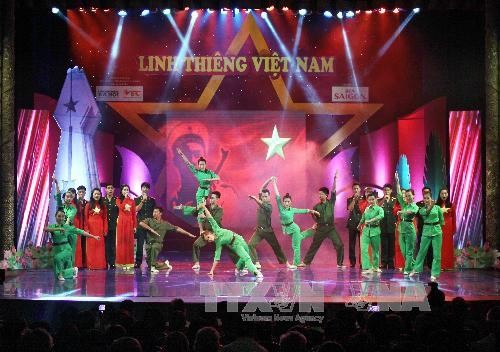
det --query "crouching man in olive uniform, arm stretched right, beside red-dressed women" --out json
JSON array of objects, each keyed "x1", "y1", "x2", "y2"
[{"x1": 139, "y1": 206, "x2": 196, "y2": 273}]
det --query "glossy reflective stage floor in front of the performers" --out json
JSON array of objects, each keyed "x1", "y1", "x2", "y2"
[{"x1": 0, "y1": 261, "x2": 500, "y2": 303}]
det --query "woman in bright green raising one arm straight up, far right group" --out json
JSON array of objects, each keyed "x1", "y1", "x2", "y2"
[{"x1": 395, "y1": 172, "x2": 418, "y2": 275}]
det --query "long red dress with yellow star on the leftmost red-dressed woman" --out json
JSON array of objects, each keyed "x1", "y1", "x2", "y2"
[{"x1": 85, "y1": 202, "x2": 108, "y2": 269}]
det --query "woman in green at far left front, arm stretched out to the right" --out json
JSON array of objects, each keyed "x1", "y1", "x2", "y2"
[{"x1": 44, "y1": 209, "x2": 99, "y2": 281}]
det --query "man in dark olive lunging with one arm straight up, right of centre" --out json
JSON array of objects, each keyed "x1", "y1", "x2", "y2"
[{"x1": 304, "y1": 171, "x2": 345, "y2": 269}]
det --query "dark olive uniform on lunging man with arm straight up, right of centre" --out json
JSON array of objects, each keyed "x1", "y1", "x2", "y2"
[{"x1": 304, "y1": 192, "x2": 344, "y2": 265}]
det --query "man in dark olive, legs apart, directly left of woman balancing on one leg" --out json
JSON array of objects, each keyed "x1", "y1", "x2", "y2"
[{"x1": 248, "y1": 177, "x2": 297, "y2": 269}]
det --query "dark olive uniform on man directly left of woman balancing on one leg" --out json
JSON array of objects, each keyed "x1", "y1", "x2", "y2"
[{"x1": 248, "y1": 203, "x2": 286, "y2": 264}]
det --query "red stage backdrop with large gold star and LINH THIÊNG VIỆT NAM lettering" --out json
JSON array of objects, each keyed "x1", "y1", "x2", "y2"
[{"x1": 19, "y1": 10, "x2": 484, "y2": 255}]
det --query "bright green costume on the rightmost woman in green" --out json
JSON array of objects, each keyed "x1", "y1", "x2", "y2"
[{"x1": 413, "y1": 205, "x2": 444, "y2": 277}]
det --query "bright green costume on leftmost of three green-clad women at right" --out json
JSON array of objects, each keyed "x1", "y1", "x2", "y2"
[{"x1": 359, "y1": 205, "x2": 384, "y2": 270}]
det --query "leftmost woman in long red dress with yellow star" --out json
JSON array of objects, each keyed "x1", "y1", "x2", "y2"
[{"x1": 85, "y1": 188, "x2": 108, "y2": 269}]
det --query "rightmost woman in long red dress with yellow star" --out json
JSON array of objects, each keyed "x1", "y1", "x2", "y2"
[{"x1": 436, "y1": 187, "x2": 456, "y2": 270}]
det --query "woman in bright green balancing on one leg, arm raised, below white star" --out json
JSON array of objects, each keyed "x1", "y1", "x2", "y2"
[{"x1": 273, "y1": 176, "x2": 321, "y2": 269}]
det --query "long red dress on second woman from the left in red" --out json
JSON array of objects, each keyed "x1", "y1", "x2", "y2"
[{"x1": 116, "y1": 197, "x2": 137, "y2": 265}]
